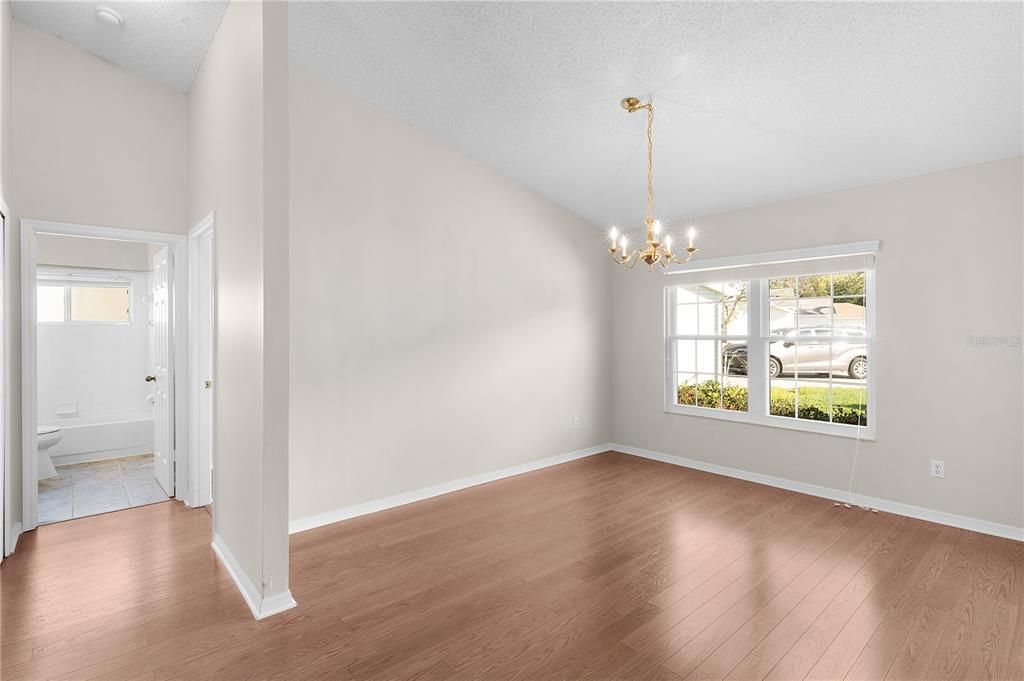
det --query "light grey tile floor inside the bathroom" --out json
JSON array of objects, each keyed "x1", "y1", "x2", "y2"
[{"x1": 39, "y1": 454, "x2": 168, "y2": 524}]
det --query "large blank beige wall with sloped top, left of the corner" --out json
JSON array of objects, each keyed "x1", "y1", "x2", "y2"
[{"x1": 290, "y1": 65, "x2": 610, "y2": 520}]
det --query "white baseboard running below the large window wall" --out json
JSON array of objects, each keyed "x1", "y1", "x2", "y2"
[{"x1": 608, "y1": 444, "x2": 1024, "y2": 542}]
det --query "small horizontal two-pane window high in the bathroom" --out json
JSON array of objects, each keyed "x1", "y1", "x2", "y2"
[{"x1": 36, "y1": 280, "x2": 131, "y2": 324}]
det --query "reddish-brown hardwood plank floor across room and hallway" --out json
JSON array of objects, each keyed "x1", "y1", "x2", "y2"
[{"x1": 0, "y1": 454, "x2": 1024, "y2": 681}]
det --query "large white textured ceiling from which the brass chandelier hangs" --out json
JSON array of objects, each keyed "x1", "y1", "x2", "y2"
[{"x1": 290, "y1": 2, "x2": 1022, "y2": 225}]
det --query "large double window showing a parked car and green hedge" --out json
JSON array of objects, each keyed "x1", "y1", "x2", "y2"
[{"x1": 665, "y1": 261, "x2": 874, "y2": 437}]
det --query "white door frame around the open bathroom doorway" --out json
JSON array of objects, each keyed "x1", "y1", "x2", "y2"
[{"x1": 20, "y1": 218, "x2": 188, "y2": 530}]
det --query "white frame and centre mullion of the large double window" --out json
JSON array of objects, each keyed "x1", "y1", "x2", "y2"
[{"x1": 664, "y1": 248, "x2": 878, "y2": 440}]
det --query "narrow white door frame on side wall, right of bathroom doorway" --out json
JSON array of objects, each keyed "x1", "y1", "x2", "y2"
[{"x1": 187, "y1": 213, "x2": 217, "y2": 506}]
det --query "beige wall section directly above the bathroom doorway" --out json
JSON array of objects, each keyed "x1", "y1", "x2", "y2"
[{"x1": 13, "y1": 22, "x2": 188, "y2": 233}]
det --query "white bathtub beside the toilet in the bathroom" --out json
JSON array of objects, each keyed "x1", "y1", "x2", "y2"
[{"x1": 40, "y1": 414, "x2": 153, "y2": 466}]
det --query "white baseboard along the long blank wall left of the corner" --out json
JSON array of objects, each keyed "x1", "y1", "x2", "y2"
[{"x1": 288, "y1": 444, "x2": 612, "y2": 535}]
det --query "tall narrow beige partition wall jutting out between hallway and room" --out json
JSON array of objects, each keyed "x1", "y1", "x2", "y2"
[{"x1": 188, "y1": 2, "x2": 288, "y2": 597}]
